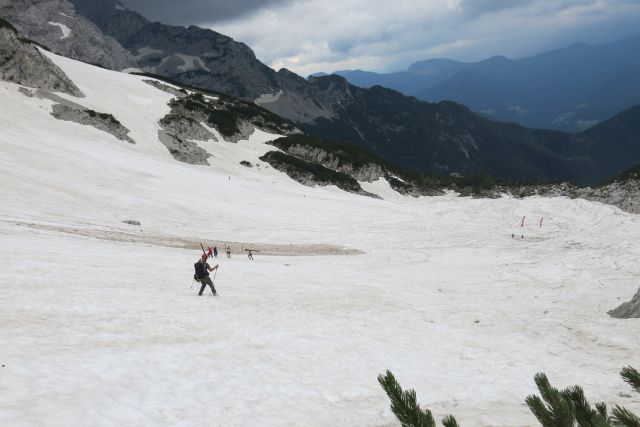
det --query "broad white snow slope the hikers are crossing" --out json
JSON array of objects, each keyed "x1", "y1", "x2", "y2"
[{"x1": 0, "y1": 54, "x2": 640, "y2": 426}]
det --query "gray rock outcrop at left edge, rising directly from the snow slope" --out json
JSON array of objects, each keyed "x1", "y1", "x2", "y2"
[{"x1": 0, "y1": 25, "x2": 84, "y2": 97}]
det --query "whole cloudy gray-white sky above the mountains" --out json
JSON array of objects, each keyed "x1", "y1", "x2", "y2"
[{"x1": 121, "y1": 0, "x2": 640, "y2": 76}]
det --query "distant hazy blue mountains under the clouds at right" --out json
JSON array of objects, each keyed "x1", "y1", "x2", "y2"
[{"x1": 336, "y1": 35, "x2": 640, "y2": 132}]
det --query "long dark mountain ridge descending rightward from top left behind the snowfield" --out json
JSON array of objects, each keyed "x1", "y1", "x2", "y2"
[{"x1": 7, "y1": 0, "x2": 626, "y2": 184}]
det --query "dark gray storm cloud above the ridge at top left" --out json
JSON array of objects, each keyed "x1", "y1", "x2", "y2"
[{"x1": 120, "y1": 0, "x2": 291, "y2": 25}]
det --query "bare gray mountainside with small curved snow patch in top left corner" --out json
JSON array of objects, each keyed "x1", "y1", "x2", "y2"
[{"x1": 0, "y1": 0, "x2": 134, "y2": 70}]
